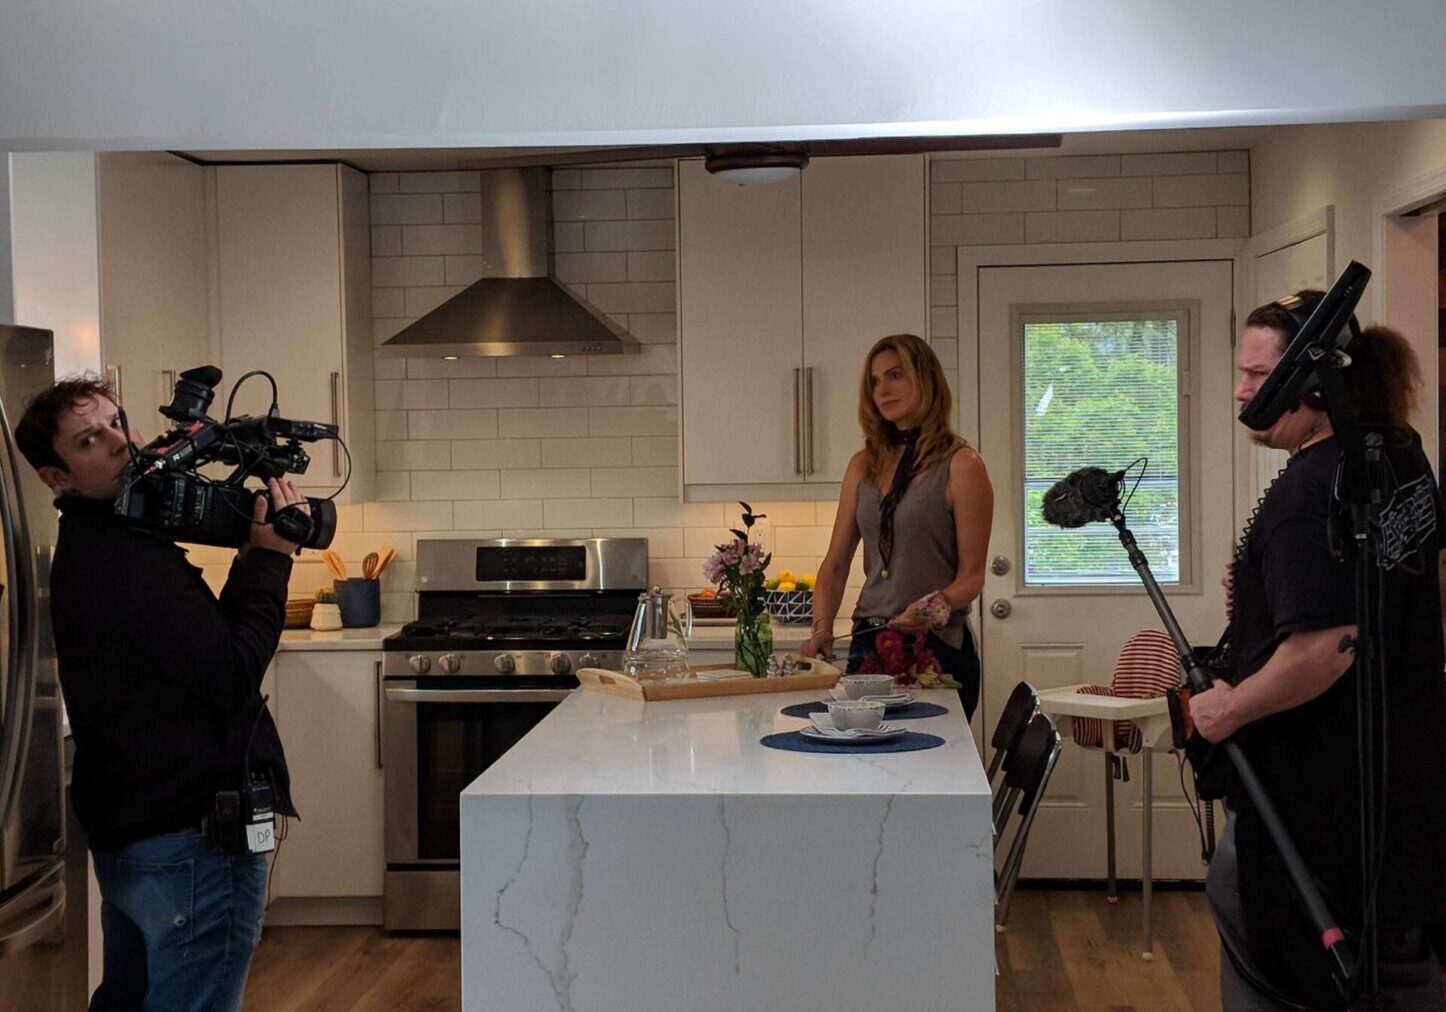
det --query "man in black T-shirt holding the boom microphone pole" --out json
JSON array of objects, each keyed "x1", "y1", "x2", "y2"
[{"x1": 1190, "y1": 300, "x2": 1446, "y2": 1012}]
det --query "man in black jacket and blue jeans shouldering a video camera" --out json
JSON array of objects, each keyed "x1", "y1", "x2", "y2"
[{"x1": 14, "y1": 377, "x2": 305, "y2": 1012}]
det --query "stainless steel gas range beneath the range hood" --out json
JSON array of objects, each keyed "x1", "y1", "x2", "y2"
[{"x1": 377, "y1": 538, "x2": 648, "y2": 931}]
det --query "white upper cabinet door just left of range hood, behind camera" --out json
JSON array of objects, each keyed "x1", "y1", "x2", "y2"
[{"x1": 213, "y1": 165, "x2": 344, "y2": 487}]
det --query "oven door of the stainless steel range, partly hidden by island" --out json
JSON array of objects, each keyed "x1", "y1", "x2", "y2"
[{"x1": 382, "y1": 678, "x2": 576, "y2": 867}]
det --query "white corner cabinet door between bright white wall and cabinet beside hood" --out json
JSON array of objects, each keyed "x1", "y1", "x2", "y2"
[{"x1": 95, "y1": 152, "x2": 213, "y2": 441}]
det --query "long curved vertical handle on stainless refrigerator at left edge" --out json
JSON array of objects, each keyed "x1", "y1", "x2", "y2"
[{"x1": 0, "y1": 406, "x2": 36, "y2": 826}]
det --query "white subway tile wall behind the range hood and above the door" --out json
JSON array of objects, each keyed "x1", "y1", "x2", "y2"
[{"x1": 234, "y1": 152, "x2": 1249, "y2": 622}]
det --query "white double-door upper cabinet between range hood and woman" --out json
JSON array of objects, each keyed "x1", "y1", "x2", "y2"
[{"x1": 678, "y1": 155, "x2": 928, "y2": 500}]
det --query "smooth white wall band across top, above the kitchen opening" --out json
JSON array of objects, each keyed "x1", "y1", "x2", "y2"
[{"x1": 0, "y1": 0, "x2": 1446, "y2": 150}]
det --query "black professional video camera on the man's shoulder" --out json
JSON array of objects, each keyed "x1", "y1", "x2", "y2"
[{"x1": 116, "y1": 366, "x2": 341, "y2": 548}]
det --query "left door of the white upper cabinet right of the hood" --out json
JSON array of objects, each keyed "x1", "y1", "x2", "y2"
[{"x1": 678, "y1": 160, "x2": 803, "y2": 484}]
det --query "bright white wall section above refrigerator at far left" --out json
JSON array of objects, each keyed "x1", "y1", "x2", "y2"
[{"x1": 10, "y1": 152, "x2": 100, "y2": 376}]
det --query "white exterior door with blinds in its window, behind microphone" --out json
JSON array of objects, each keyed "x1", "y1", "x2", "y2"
[{"x1": 960, "y1": 260, "x2": 1235, "y2": 879}]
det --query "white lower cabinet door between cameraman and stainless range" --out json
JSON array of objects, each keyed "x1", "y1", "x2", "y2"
[{"x1": 273, "y1": 651, "x2": 383, "y2": 896}]
